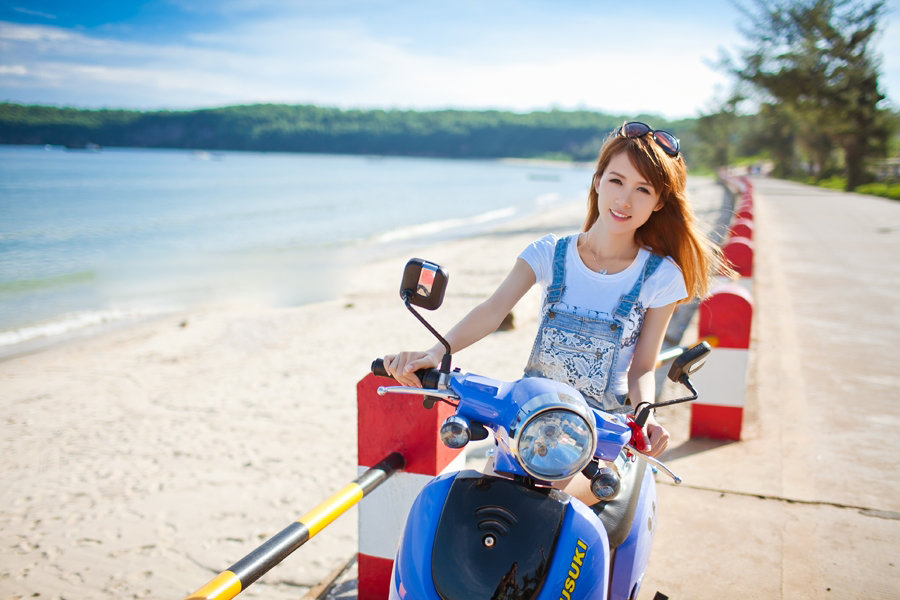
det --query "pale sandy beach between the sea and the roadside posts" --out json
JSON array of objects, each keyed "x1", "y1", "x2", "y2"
[{"x1": 0, "y1": 178, "x2": 723, "y2": 600}]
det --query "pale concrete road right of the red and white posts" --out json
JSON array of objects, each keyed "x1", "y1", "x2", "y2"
[{"x1": 641, "y1": 178, "x2": 900, "y2": 600}]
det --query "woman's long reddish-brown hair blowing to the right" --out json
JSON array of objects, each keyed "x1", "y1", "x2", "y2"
[{"x1": 584, "y1": 131, "x2": 733, "y2": 302}]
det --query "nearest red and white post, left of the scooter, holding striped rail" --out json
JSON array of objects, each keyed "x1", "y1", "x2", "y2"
[{"x1": 356, "y1": 375, "x2": 465, "y2": 600}]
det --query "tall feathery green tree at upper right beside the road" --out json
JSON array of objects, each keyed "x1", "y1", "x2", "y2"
[{"x1": 732, "y1": 0, "x2": 890, "y2": 189}]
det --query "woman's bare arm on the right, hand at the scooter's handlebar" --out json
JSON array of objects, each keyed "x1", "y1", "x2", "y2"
[{"x1": 628, "y1": 302, "x2": 675, "y2": 456}]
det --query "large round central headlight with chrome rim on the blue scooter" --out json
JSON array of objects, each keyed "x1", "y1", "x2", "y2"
[{"x1": 516, "y1": 407, "x2": 596, "y2": 481}]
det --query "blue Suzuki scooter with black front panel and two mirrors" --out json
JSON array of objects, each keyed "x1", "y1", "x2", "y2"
[{"x1": 372, "y1": 259, "x2": 710, "y2": 600}]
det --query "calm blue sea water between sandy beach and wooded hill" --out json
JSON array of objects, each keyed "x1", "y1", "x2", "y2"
[{"x1": 0, "y1": 146, "x2": 591, "y2": 356}]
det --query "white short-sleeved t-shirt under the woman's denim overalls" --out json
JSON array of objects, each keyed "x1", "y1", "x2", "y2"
[{"x1": 519, "y1": 234, "x2": 687, "y2": 394}]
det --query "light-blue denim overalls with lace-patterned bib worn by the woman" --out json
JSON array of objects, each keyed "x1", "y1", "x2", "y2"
[{"x1": 525, "y1": 235, "x2": 662, "y2": 413}]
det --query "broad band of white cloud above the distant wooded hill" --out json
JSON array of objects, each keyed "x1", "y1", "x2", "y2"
[{"x1": 0, "y1": 0, "x2": 888, "y2": 117}]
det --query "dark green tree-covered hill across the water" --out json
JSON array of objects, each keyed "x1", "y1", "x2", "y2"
[{"x1": 0, "y1": 104, "x2": 696, "y2": 160}]
